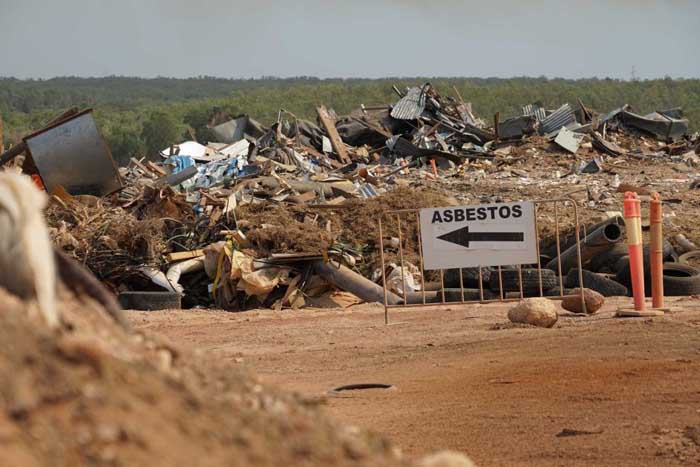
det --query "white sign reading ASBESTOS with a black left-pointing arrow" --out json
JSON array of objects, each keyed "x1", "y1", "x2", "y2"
[{"x1": 420, "y1": 201, "x2": 538, "y2": 269}]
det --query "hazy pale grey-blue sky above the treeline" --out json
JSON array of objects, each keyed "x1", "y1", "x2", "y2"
[{"x1": 0, "y1": 0, "x2": 700, "y2": 79}]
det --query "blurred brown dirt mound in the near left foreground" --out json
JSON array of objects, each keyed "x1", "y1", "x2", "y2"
[{"x1": 0, "y1": 288, "x2": 410, "y2": 467}]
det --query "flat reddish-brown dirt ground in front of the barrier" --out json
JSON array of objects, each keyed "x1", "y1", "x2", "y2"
[{"x1": 128, "y1": 298, "x2": 700, "y2": 466}]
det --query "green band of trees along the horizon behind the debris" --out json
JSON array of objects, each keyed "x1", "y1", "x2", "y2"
[{"x1": 0, "y1": 77, "x2": 700, "y2": 163}]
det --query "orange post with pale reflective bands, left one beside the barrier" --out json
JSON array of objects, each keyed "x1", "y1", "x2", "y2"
[{"x1": 624, "y1": 191, "x2": 644, "y2": 311}]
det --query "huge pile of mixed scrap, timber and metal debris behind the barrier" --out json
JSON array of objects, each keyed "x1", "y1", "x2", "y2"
[{"x1": 0, "y1": 83, "x2": 700, "y2": 310}]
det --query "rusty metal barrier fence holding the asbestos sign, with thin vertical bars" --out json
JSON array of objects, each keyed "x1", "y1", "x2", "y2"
[{"x1": 378, "y1": 198, "x2": 586, "y2": 324}]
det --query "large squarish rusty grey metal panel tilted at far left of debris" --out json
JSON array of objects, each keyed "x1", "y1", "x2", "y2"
[{"x1": 24, "y1": 109, "x2": 123, "y2": 196}]
